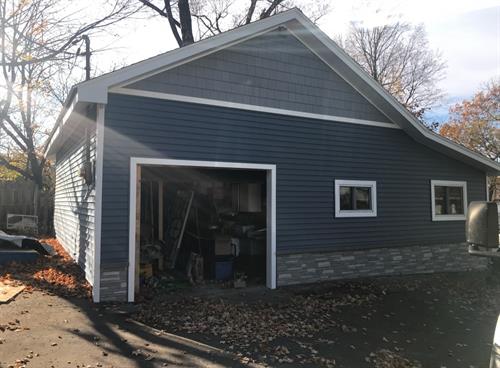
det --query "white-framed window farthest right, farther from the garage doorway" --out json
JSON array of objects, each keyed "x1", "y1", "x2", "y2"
[{"x1": 431, "y1": 180, "x2": 467, "y2": 221}]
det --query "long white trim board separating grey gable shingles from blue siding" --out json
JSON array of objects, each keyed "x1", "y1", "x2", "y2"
[{"x1": 110, "y1": 88, "x2": 401, "y2": 129}]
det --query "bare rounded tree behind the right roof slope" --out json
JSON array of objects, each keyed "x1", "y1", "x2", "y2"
[{"x1": 339, "y1": 22, "x2": 446, "y2": 117}]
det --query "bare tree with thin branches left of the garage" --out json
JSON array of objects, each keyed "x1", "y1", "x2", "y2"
[{"x1": 0, "y1": 0, "x2": 137, "y2": 210}]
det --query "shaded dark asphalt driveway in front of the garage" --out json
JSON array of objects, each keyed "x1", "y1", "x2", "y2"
[{"x1": 134, "y1": 271, "x2": 500, "y2": 368}]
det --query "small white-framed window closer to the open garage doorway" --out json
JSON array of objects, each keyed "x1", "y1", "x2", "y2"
[{"x1": 335, "y1": 180, "x2": 377, "y2": 217}]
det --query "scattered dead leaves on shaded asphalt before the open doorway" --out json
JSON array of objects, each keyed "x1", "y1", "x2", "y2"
[{"x1": 135, "y1": 290, "x2": 376, "y2": 367}]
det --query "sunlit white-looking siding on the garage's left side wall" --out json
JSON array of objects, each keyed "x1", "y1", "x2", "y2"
[{"x1": 54, "y1": 123, "x2": 95, "y2": 283}]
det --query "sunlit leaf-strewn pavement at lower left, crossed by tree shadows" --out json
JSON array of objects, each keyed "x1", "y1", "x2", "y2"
[{"x1": 0, "y1": 239, "x2": 258, "y2": 368}]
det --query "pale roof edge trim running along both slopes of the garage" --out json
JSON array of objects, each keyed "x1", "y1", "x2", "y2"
[{"x1": 46, "y1": 9, "x2": 500, "y2": 175}]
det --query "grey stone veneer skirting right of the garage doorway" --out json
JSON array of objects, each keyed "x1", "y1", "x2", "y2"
[{"x1": 277, "y1": 243, "x2": 488, "y2": 286}]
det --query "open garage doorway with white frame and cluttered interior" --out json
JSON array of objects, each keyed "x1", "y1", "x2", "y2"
[{"x1": 128, "y1": 158, "x2": 276, "y2": 301}]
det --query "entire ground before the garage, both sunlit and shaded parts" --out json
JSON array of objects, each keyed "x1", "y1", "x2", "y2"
[{"x1": 0, "y1": 240, "x2": 500, "y2": 368}]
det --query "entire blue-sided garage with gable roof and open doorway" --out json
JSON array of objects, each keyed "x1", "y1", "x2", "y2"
[{"x1": 46, "y1": 10, "x2": 499, "y2": 302}]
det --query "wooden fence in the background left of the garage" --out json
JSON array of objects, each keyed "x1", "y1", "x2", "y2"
[{"x1": 0, "y1": 180, "x2": 54, "y2": 235}]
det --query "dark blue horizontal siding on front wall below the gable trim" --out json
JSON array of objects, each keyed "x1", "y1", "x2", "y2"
[{"x1": 102, "y1": 94, "x2": 485, "y2": 264}]
